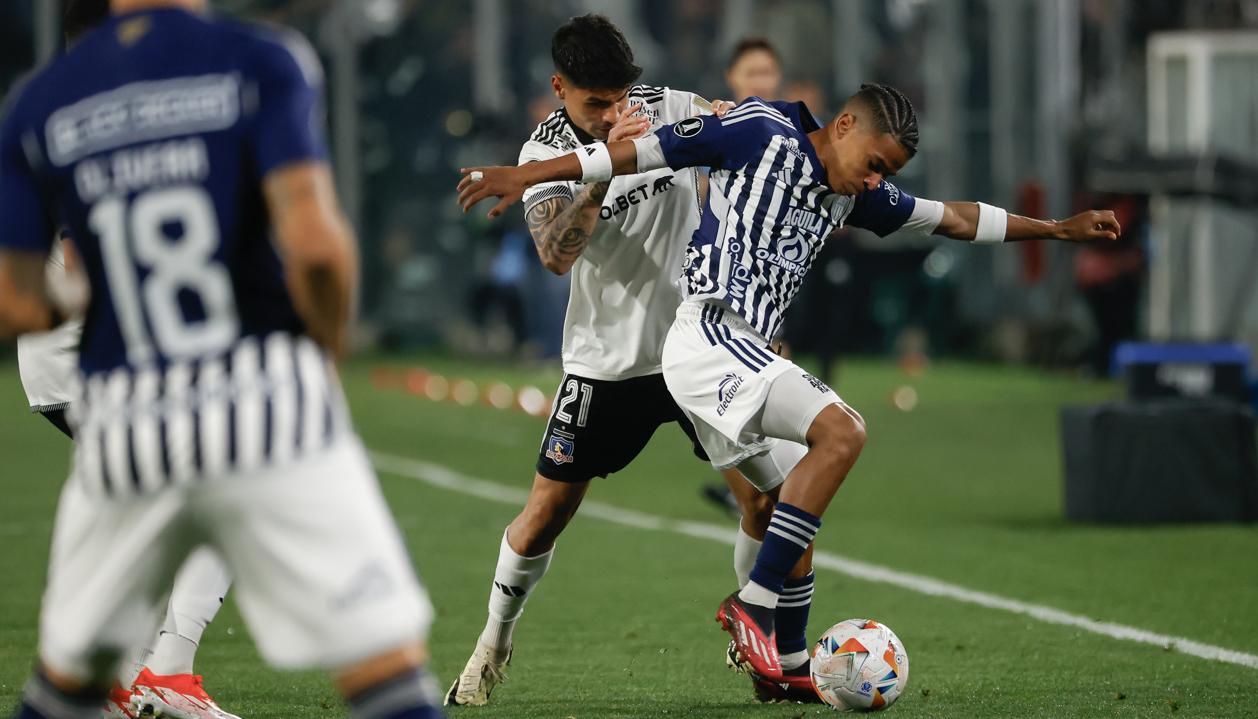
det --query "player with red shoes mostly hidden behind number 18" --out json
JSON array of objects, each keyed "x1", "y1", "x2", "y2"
[{"x1": 18, "y1": 7, "x2": 239, "y2": 719}]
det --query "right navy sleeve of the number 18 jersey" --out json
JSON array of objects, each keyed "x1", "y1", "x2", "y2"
[{"x1": 247, "y1": 33, "x2": 327, "y2": 176}]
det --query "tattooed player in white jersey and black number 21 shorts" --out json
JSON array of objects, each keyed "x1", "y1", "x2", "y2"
[{"x1": 447, "y1": 15, "x2": 811, "y2": 705}]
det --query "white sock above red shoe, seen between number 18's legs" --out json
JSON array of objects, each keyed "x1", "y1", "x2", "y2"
[{"x1": 148, "y1": 547, "x2": 231, "y2": 675}]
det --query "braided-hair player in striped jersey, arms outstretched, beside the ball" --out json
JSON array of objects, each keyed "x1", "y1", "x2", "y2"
[{"x1": 459, "y1": 85, "x2": 1121, "y2": 699}]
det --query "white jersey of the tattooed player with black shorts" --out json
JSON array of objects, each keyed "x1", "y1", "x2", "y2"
[{"x1": 520, "y1": 85, "x2": 708, "y2": 380}]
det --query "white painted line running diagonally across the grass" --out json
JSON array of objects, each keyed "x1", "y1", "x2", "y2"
[{"x1": 371, "y1": 451, "x2": 1258, "y2": 669}]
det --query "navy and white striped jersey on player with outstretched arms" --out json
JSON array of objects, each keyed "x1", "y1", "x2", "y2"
[{"x1": 639, "y1": 97, "x2": 920, "y2": 339}]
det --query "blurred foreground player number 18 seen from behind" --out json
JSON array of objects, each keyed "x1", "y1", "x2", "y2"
[{"x1": 0, "y1": 0, "x2": 442, "y2": 719}]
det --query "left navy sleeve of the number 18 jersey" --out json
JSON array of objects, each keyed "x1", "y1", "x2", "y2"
[{"x1": 0, "y1": 92, "x2": 57, "y2": 253}]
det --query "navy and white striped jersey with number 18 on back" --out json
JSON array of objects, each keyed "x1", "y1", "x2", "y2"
[{"x1": 0, "y1": 8, "x2": 348, "y2": 494}]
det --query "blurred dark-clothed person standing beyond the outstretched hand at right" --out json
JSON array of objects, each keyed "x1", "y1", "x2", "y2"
[{"x1": 1074, "y1": 195, "x2": 1147, "y2": 377}]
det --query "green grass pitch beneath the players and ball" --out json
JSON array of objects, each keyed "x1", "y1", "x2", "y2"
[{"x1": 0, "y1": 357, "x2": 1258, "y2": 719}]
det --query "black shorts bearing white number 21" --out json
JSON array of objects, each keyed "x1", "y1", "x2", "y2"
[{"x1": 537, "y1": 375, "x2": 708, "y2": 481}]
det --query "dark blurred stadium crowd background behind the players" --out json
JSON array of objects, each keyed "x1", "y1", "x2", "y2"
[{"x1": 0, "y1": 0, "x2": 1258, "y2": 375}]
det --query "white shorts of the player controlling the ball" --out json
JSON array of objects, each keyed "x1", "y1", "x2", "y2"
[{"x1": 663, "y1": 300, "x2": 843, "y2": 469}]
